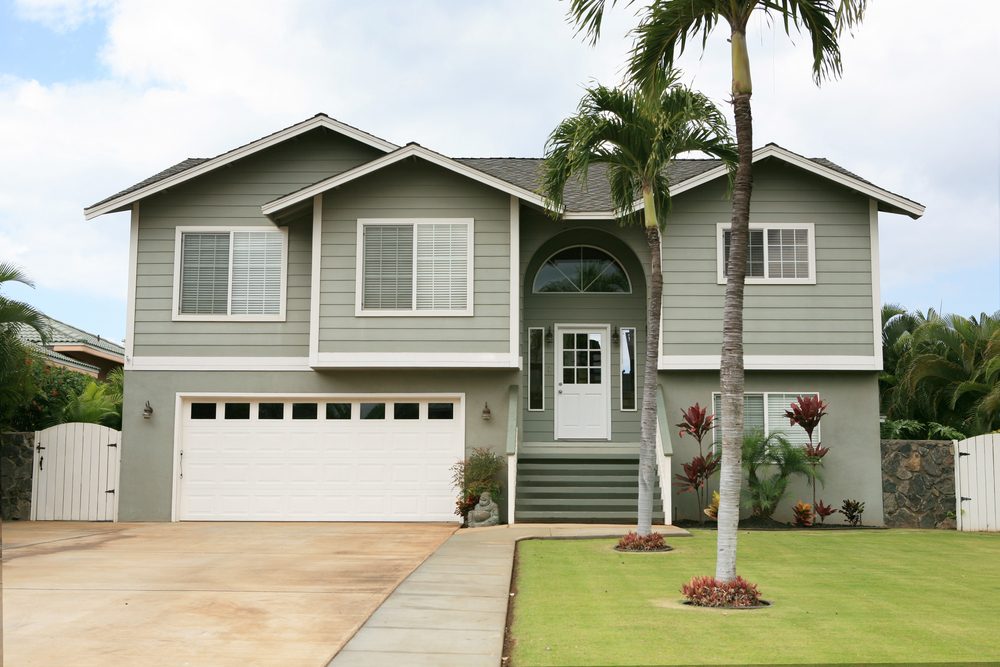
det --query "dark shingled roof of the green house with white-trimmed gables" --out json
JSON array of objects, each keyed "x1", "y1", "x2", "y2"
[{"x1": 90, "y1": 114, "x2": 924, "y2": 220}]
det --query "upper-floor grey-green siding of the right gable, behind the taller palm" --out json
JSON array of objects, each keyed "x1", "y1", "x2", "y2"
[{"x1": 661, "y1": 160, "x2": 874, "y2": 356}]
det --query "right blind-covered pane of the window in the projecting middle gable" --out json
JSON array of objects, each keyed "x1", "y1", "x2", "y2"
[{"x1": 417, "y1": 223, "x2": 469, "y2": 310}]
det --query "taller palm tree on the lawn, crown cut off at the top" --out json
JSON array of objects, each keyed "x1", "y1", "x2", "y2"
[{"x1": 569, "y1": 0, "x2": 867, "y2": 581}]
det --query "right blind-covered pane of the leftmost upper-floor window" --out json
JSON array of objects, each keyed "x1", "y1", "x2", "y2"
[{"x1": 231, "y1": 231, "x2": 284, "y2": 315}]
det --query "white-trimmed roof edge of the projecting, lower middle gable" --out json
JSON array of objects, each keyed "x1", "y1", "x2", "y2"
[{"x1": 261, "y1": 143, "x2": 544, "y2": 215}]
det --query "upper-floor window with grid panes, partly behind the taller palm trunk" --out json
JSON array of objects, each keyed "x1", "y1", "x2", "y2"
[{"x1": 716, "y1": 222, "x2": 816, "y2": 285}]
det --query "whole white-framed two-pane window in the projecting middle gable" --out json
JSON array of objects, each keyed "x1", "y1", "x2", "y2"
[{"x1": 356, "y1": 218, "x2": 473, "y2": 316}]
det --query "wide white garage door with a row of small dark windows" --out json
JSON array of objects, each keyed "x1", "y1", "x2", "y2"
[{"x1": 177, "y1": 396, "x2": 465, "y2": 521}]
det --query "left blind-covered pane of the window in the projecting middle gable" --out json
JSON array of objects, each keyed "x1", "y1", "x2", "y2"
[{"x1": 361, "y1": 225, "x2": 413, "y2": 310}]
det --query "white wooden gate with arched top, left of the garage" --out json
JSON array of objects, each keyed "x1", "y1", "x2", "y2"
[{"x1": 31, "y1": 424, "x2": 121, "y2": 521}]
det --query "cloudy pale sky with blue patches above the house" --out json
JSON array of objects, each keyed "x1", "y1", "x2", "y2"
[{"x1": 0, "y1": 0, "x2": 1000, "y2": 340}]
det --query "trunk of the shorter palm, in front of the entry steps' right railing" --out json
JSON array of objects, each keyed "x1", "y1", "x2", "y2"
[{"x1": 640, "y1": 189, "x2": 663, "y2": 535}]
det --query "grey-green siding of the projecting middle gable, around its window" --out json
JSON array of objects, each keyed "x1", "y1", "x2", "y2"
[{"x1": 319, "y1": 161, "x2": 511, "y2": 353}]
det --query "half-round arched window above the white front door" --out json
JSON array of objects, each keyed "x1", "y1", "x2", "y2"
[{"x1": 532, "y1": 246, "x2": 632, "y2": 294}]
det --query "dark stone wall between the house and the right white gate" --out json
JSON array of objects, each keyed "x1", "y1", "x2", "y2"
[{"x1": 882, "y1": 440, "x2": 955, "y2": 530}]
